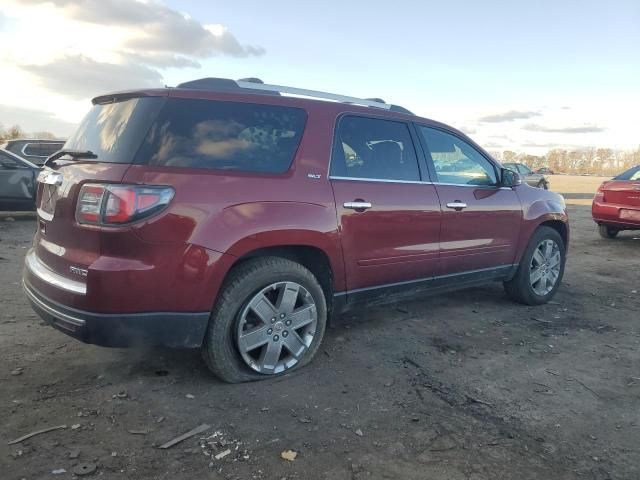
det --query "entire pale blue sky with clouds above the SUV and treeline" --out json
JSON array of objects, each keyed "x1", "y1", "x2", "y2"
[{"x1": 0, "y1": 0, "x2": 640, "y2": 154}]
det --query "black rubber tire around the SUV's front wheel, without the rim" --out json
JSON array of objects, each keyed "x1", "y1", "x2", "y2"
[{"x1": 504, "y1": 226, "x2": 567, "y2": 305}]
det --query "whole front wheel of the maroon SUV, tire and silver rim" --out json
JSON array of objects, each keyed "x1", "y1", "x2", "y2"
[{"x1": 504, "y1": 226, "x2": 566, "y2": 305}]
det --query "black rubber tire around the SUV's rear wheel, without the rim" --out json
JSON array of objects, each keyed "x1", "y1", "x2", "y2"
[{"x1": 202, "y1": 257, "x2": 327, "y2": 383}]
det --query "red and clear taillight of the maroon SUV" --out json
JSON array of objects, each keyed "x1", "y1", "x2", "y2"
[{"x1": 76, "y1": 183, "x2": 174, "y2": 225}]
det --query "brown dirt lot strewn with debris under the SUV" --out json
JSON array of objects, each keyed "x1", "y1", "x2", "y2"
[{"x1": 0, "y1": 180, "x2": 640, "y2": 480}]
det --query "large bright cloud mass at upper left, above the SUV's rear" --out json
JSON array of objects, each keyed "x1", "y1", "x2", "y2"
[{"x1": 0, "y1": 0, "x2": 264, "y2": 133}]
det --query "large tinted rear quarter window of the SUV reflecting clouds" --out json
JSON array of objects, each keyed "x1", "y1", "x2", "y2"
[{"x1": 136, "y1": 99, "x2": 306, "y2": 173}]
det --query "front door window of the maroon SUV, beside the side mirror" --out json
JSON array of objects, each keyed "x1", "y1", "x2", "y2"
[{"x1": 419, "y1": 127, "x2": 498, "y2": 185}]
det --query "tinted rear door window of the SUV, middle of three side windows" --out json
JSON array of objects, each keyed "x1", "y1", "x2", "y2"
[{"x1": 331, "y1": 117, "x2": 420, "y2": 181}]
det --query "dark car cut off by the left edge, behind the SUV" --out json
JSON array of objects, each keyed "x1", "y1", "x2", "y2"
[{"x1": 0, "y1": 149, "x2": 40, "y2": 211}]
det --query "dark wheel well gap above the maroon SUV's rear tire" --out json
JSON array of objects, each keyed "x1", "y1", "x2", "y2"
[{"x1": 232, "y1": 245, "x2": 333, "y2": 312}]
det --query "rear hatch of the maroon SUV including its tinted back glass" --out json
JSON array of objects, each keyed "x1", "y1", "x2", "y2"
[{"x1": 34, "y1": 94, "x2": 166, "y2": 288}]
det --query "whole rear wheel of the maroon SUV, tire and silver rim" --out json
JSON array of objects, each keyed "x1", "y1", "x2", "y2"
[{"x1": 202, "y1": 257, "x2": 327, "y2": 383}]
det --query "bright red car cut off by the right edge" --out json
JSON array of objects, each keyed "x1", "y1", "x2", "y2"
[{"x1": 591, "y1": 165, "x2": 640, "y2": 238}]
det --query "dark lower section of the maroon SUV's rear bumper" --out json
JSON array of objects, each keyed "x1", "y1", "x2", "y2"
[{"x1": 23, "y1": 280, "x2": 209, "y2": 348}]
